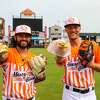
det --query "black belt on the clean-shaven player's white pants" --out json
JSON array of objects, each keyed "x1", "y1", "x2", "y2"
[{"x1": 65, "y1": 85, "x2": 94, "y2": 94}]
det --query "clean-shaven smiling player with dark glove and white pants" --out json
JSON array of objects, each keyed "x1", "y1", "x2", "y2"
[{"x1": 56, "y1": 17, "x2": 100, "y2": 100}]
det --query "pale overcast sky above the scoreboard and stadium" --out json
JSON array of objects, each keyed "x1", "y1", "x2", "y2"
[{"x1": 0, "y1": 0, "x2": 100, "y2": 32}]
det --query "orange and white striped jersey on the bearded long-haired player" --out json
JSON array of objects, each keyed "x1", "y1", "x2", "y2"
[{"x1": 2, "y1": 48, "x2": 36, "y2": 100}]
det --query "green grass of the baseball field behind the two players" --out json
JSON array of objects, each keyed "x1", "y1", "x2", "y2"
[{"x1": 0, "y1": 48, "x2": 100, "y2": 100}]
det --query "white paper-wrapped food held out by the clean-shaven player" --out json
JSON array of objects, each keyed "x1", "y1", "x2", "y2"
[{"x1": 47, "y1": 39, "x2": 71, "y2": 57}]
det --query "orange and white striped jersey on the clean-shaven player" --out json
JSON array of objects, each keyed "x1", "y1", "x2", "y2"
[{"x1": 64, "y1": 42, "x2": 100, "y2": 88}]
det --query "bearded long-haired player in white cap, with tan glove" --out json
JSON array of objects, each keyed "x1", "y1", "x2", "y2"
[{"x1": 0, "y1": 25, "x2": 46, "y2": 100}]
